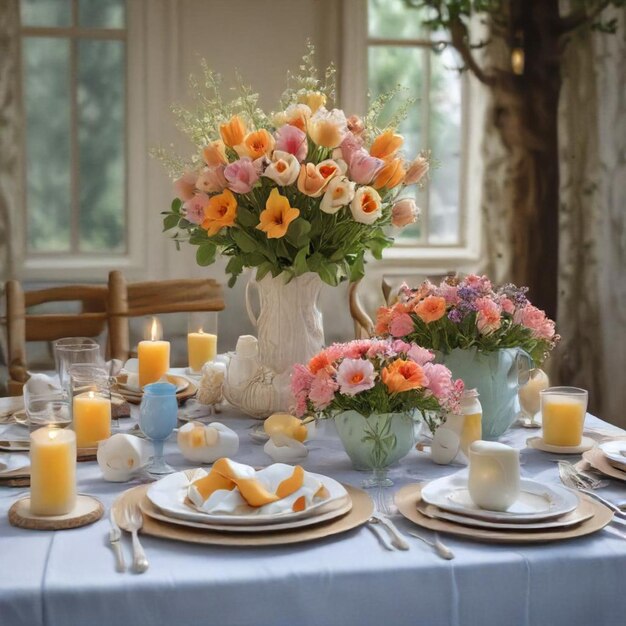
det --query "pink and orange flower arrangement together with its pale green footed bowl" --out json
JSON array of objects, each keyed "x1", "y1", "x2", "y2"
[{"x1": 291, "y1": 339, "x2": 463, "y2": 472}]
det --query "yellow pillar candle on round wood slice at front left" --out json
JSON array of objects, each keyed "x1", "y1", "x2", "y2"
[{"x1": 30, "y1": 427, "x2": 76, "y2": 515}]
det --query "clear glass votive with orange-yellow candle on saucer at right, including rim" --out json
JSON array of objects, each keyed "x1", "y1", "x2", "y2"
[{"x1": 541, "y1": 387, "x2": 588, "y2": 447}]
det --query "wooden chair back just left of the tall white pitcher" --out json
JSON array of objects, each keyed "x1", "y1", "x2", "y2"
[{"x1": 108, "y1": 271, "x2": 225, "y2": 361}]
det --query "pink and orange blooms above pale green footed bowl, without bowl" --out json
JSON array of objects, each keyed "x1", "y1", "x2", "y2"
[{"x1": 291, "y1": 339, "x2": 463, "y2": 417}]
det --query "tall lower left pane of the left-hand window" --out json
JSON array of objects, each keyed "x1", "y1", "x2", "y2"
[{"x1": 22, "y1": 37, "x2": 71, "y2": 252}]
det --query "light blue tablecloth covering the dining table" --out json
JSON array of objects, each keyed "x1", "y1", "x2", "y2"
[{"x1": 0, "y1": 372, "x2": 626, "y2": 626}]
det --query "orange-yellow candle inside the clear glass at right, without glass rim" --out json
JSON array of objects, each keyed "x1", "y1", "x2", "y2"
[{"x1": 541, "y1": 396, "x2": 586, "y2": 446}]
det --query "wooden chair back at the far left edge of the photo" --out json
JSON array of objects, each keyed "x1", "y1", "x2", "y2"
[{"x1": 5, "y1": 280, "x2": 108, "y2": 396}]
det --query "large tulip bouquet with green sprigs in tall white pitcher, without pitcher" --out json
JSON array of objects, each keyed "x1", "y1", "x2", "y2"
[{"x1": 157, "y1": 48, "x2": 428, "y2": 286}]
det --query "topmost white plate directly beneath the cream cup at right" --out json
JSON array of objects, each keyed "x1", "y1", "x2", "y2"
[{"x1": 422, "y1": 470, "x2": 578, "y2": 524}]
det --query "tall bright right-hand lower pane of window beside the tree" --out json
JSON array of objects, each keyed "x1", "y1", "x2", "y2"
[{"x1": 428, "y1": 48, "x2": 462, "y2": 244}]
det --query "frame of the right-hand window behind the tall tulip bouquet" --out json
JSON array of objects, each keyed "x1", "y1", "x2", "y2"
[{"x1": 340, "y1": 0, "x2": 485, "y2": 274}]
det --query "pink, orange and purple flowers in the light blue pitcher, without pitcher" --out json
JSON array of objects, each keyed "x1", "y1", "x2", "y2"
[{"x1": 376, "y1": 275, "x2": 559, "y2": 363}]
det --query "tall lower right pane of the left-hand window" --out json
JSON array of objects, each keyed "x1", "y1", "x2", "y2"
[{"x1": 78, "y1": 40, "x2": 126, "y2": 252}]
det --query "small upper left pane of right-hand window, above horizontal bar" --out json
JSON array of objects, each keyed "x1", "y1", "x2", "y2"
[{"x1": 367, "y1": 0, "x2": 424, "y2": 39}]
